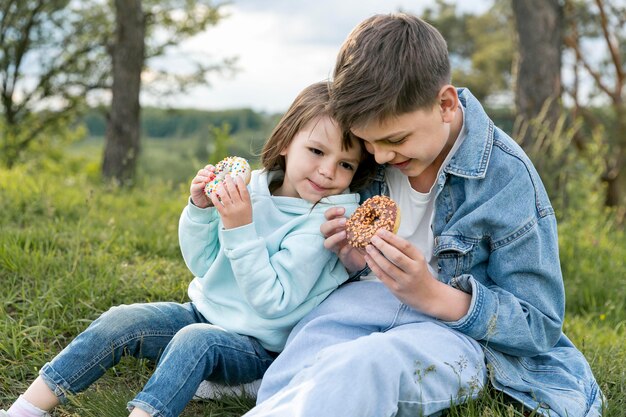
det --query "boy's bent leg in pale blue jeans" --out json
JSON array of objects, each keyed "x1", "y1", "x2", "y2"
[{"x1": 246, "y1": 322, "x2": 486, "y2": 417}]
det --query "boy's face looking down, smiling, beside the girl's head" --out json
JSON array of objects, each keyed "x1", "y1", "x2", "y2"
[{"x1": 351, "y1": 105, "x2": 456, "y2": 177}]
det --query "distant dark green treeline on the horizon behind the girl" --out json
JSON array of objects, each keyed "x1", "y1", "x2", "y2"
[{"x1": 83, "y1": 107, "x2": 280, "y2": 138}]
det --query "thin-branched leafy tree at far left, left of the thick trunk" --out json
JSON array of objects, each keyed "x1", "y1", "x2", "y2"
[{"x1": 0, "y1": 0, "x2": 107, "y2": 166}]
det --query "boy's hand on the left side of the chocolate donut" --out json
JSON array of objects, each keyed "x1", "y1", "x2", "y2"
[{"x1": 320, "y1": 207, "x2": 365, "y2": 273}]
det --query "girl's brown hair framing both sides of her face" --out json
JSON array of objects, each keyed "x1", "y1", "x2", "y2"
[{"x1": 261, "y1": 81, "x2": 374, "y2": 191}]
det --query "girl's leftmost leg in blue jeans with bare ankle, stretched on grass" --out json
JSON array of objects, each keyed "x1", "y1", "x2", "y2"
[{"x1": 11, "y1": 303, "x2": 202, "y2": 411}]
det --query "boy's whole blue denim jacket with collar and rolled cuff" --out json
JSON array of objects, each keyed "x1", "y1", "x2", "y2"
[{"x1": 361, "y1": 89, "x2": 603, "y2": 417}]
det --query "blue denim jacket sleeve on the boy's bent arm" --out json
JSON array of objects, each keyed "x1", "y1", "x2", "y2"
[{"x1": 435, "y1": 138, "x2": 565, "y2": 356}]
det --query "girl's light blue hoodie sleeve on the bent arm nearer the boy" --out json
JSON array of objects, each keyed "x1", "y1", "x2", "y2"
[{"x1": 221, "y1": 224, "x2": 348, "y2": 318}]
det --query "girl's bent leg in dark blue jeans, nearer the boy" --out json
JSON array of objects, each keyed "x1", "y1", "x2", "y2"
[{"x1": 128, "y1": 323, "x2": 273, "y2": 416}]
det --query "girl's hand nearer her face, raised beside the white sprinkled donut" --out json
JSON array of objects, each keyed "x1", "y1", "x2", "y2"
[{"x1": 211, "y1": 175, "x2": 252, "y2": 229}]
